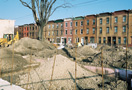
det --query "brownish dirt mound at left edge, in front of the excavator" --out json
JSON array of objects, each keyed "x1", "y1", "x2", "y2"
[{"x1": 0, "y1": 48, "x2": 28, "y2": 72}]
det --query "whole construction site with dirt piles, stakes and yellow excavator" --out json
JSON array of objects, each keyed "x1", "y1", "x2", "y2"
[{"x1": 0, "y1": 20, "x2": 132, "y2": 90}]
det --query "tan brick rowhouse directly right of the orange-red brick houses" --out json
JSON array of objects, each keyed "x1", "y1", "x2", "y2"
[{"x1": 97, "y1": 12, "x2": 113, "y2": 44}]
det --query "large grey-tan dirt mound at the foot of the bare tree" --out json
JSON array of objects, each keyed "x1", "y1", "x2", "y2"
[{"x1": 10, "y1": 37, "x2": 55, "y2": 57}]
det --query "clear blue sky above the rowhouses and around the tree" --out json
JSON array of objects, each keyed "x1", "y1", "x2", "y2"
[{"x1": 0, "y1": 0, "x2": 132, "y2": 25}]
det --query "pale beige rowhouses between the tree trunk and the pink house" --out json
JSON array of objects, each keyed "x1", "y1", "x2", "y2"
[{"x1": 44, "y1": 19, "x2": 64, "y2": 43}]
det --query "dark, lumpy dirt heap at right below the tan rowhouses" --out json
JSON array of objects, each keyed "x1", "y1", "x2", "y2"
[{"x1": 81, "y1": 45, "x2": 132, "y2": 69}]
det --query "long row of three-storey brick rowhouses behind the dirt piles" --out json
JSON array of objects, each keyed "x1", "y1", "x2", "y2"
[{"x1": 14, "y1": 10, "x2": 132, "y2": 44}]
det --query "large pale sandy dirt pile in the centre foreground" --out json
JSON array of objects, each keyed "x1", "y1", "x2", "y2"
[{"x1": 18, "y1": 55, "x2": 101, "y2": 90}]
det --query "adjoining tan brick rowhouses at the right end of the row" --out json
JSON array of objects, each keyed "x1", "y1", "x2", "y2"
[{"x1": 97, "y1": 10, "x2": 132, "y2": 45}]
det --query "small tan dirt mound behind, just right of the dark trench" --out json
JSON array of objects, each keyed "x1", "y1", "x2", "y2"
[{"x1": 63, "y1": 45, "x2": 100, "y2": 62}]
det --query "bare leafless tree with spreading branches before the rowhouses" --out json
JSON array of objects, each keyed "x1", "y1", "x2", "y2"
[{"x1": 20, "y1": 0, "x2": 69, "y2": 41}]
